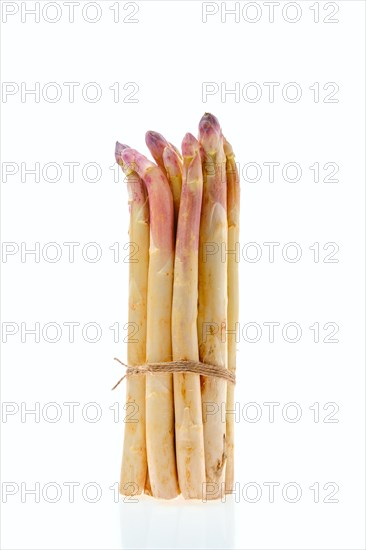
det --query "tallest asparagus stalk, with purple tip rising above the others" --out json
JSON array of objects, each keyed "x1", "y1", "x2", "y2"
[{"x1": 198, "y1": 113, "x2": 228, "y2": 499}]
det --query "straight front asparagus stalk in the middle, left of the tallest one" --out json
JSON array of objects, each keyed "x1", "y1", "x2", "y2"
[{"x1": 172, "y1": 134, "x2": 206, "y2": 498}]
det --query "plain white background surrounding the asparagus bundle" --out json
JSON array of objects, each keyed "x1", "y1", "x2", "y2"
[{"x1": 1, "y1": 0, "x2": 365, "y2": 549}]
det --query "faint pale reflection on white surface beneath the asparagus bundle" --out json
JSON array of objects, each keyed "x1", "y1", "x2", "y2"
[{"x1": 120, "y1": 496, "x2": 234, "y2": 550}]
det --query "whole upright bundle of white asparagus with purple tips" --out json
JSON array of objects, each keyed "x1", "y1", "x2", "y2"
[{"x1": 115, "y1": 113, "x2": 239, "y2": 499}]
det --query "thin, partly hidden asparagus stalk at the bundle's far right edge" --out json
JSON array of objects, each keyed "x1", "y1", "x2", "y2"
[{"x1": 224, "y1": 139, "x2": 240, "y2": 492}]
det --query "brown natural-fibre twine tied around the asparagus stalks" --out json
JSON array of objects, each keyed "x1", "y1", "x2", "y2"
[{"x1": 112, "y1": 357, "x2": 235, "y2": 390}]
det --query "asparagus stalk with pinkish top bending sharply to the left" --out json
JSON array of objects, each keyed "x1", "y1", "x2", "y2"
[{"x1": 122, "y1": 149, "x2": 178, "y2": 499}]
